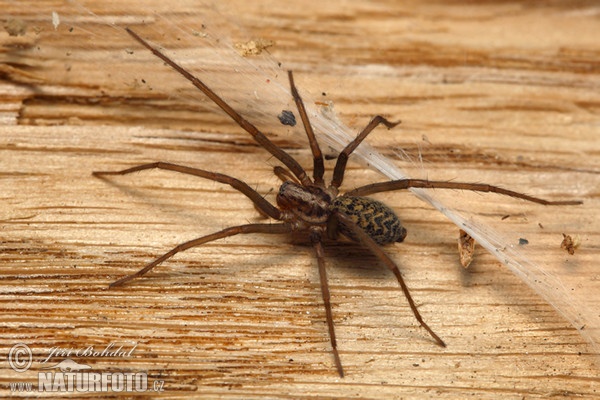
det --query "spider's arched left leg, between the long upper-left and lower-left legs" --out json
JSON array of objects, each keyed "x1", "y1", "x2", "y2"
[{"x1": 92, "y1": 162, "x2": 281, "y2": 220}]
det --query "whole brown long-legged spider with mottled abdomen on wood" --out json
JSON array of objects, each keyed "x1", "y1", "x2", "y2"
[{"x1": 93, "y1": 28, "x2": 582, "y2": 377}]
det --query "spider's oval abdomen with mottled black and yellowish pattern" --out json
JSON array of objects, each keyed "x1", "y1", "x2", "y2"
[{"x1": 331, "y1": 196, "x2": 406, "y2": 244}]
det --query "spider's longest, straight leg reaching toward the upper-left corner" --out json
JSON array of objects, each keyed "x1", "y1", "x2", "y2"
[{"x1": 125, "y1": 28, "x2": 312, "y2": 185}]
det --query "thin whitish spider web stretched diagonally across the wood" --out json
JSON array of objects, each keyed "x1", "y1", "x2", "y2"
[{"x1": 7, "y1": 1, "x2": 600, "y2": 360}]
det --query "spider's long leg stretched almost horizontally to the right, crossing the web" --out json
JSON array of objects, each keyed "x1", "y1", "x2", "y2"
[{"x1": 345, "y1": 179, "x2": 583, "y2": 206}]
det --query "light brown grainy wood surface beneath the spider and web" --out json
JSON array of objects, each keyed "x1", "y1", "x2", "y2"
[{"x1": 0, "y1": 0, "x2": 600, "y2": 399}]
